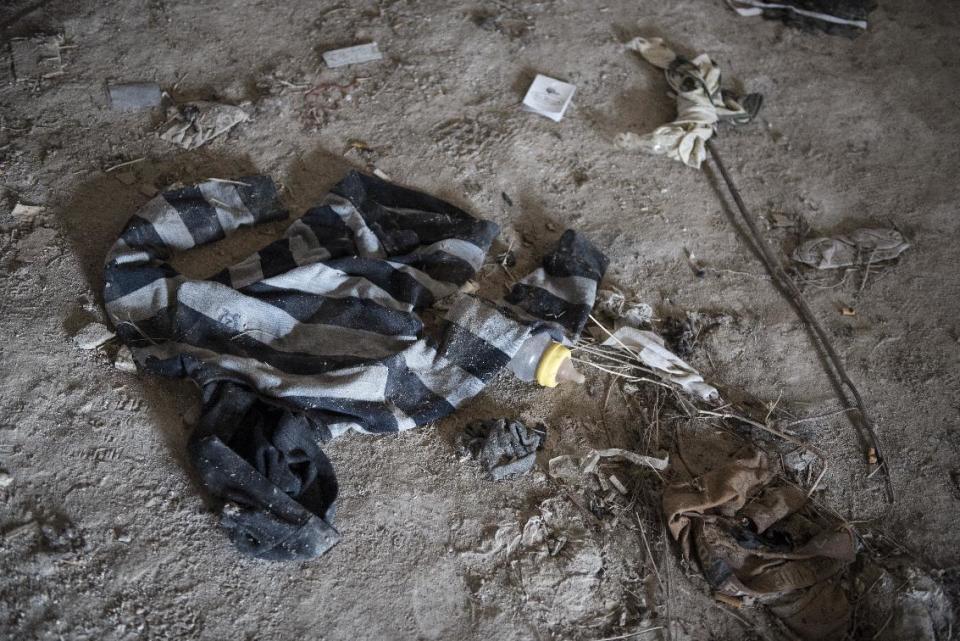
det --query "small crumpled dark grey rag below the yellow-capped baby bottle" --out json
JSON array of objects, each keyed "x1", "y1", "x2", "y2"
[{"x1": 457, "y1": 418, "x2": 546, "y2": 481}]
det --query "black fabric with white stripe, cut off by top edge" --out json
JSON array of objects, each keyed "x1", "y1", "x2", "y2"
[{"x1": 727, "y1": 0, "x2": 877, "y2": 38}]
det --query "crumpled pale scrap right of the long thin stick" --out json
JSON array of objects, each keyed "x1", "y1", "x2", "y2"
[{"x1": 793, "y1": 227, "x2": 910, "y2": 269}]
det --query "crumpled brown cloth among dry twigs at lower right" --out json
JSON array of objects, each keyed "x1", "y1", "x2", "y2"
[{"x1": 663, "y1": 448, "x2": 856, "y2": 640}]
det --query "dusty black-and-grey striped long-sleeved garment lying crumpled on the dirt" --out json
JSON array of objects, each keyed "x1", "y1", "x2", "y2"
[{"x1": 104, "y1": 172, "x2": 607, "y2": 560}]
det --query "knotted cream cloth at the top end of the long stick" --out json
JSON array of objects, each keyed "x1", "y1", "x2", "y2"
[{"x1": 616, "y1": 38, "x2": 762, "y2": 169}]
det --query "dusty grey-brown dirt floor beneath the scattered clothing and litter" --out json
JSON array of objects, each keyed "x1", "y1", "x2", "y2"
[{"x1": 0, "y1": 0, "x2": 960, "y2": 641}]
